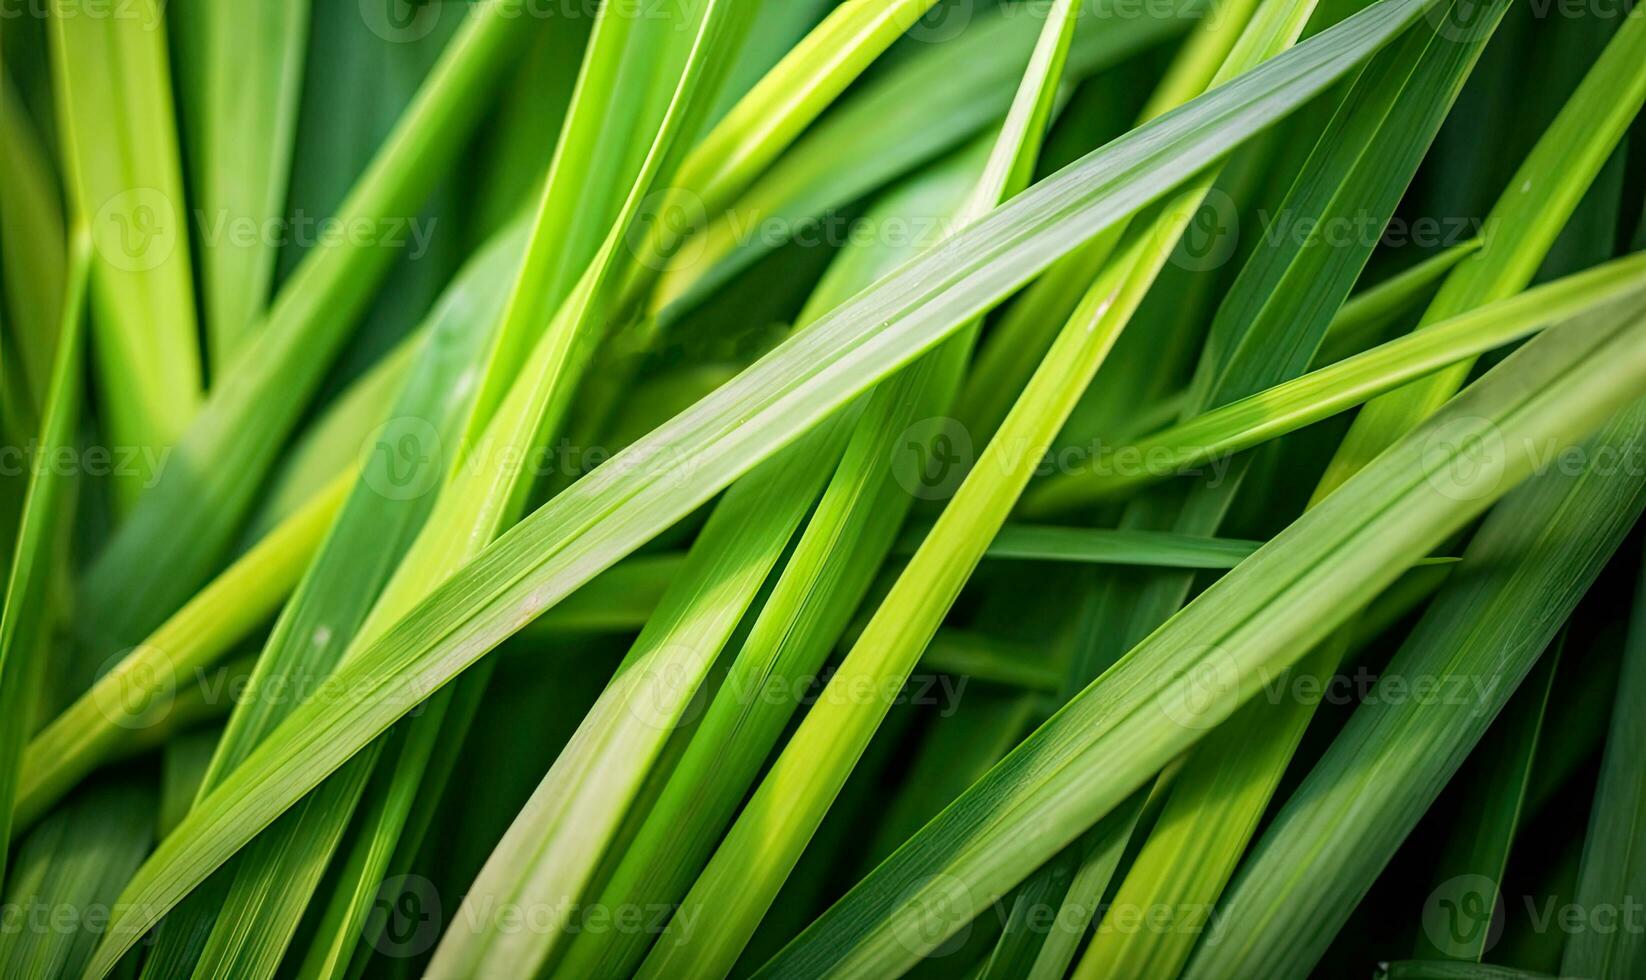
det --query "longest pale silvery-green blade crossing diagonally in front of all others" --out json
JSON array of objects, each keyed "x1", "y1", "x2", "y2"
[{"x1": 77, "y1": 11, "x2": 1424, "y2": 973}]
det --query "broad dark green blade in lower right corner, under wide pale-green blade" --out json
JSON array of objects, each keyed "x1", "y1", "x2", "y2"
[{"x1": 1188, "y1": 375, "x2": 1646, "y2": 977}]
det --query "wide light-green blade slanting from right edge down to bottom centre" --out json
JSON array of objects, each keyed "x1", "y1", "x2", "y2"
[{"x1": 764, "y1": 294, "x2": 1646, "y2": 977}]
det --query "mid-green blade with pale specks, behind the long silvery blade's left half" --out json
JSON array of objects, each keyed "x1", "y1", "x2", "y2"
[{"x1": 146, "y1": 224, "x2": 525, "y2": 977}]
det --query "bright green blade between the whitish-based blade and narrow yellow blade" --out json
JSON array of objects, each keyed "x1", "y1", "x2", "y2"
[{"x1": 560, "y1": 152, "x2": 984, "y2": 975}]
